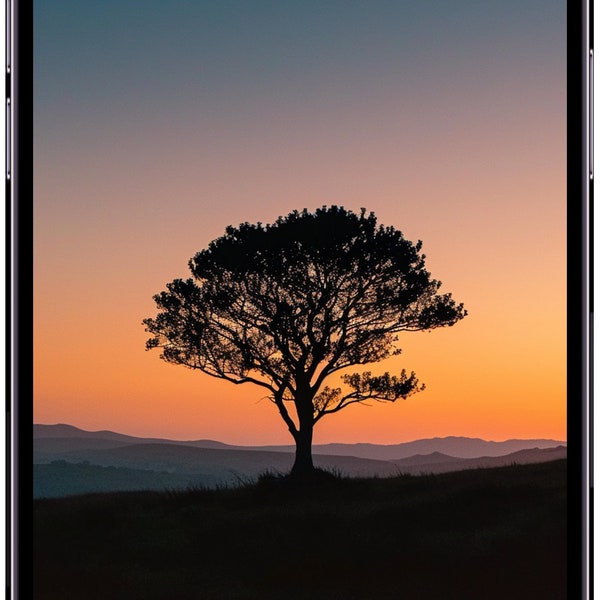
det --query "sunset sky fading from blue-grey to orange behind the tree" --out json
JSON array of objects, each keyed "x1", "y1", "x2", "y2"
[{"x1": 34, "y1": 0, "x2": 566, "y2": 444}]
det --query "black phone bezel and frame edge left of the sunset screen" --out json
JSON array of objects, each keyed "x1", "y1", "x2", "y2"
[{"x1": 7, "y1": 0, "x2": 33, "y2": 599}]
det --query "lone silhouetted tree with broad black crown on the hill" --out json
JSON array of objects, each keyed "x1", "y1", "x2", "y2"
[{"x1": 144, "y1": 206, "x2": 467, "y2": 475}]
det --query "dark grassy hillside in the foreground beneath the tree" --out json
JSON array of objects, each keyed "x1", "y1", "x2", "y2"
[{"x1": 33, "y1": 460, "x2": 566, "y2": 600}]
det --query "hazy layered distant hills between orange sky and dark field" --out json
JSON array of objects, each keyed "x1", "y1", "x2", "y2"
[{"x1": 33, "y1": 424, "x2": 567, "y2": 497}]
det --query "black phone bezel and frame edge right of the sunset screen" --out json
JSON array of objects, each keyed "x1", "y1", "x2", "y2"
[{"x1": 567, "y1": 0, "x2": 592, "y2": 598}]
